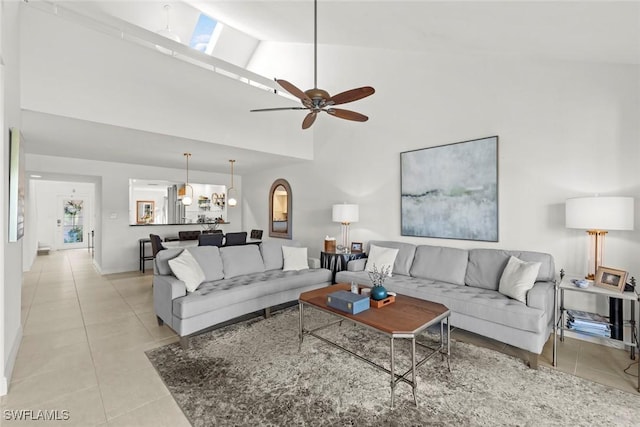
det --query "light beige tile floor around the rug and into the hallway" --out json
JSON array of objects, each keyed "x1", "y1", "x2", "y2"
[{"x1": 0, "y1": 249, "x2": 637, "y2": 427}]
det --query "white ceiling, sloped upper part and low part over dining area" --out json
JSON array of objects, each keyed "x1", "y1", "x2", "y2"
[{"x1": 23, "y1": 0, "x2": 640, "y2": 174}]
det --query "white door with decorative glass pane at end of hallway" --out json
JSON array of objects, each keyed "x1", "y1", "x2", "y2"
[{"x1": 57, "y1": 197, "x2": 89, "y2": 249}]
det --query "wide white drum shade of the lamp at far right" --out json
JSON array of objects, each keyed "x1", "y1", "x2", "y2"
[{"x1": 565, "y1": 197, "x2": 634, "y2": 230}]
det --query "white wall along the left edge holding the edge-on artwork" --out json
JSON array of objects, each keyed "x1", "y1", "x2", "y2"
[{"x1": 0, "y1": 0, "x2": 22, "y2": 395}]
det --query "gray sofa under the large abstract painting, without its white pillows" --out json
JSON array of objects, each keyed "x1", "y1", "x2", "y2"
[{"x1": 336, "y1": 241, "x2": 555, "y2": 367}]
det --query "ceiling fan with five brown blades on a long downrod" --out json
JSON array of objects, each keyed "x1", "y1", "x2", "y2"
[{"x1": 250, "y1": 0, "x2": 375, "y2": 129}]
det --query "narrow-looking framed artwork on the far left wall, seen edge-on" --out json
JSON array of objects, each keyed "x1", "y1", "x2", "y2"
[{"x1": 9, "y1": 128, "x2": 26, "y2": 242}]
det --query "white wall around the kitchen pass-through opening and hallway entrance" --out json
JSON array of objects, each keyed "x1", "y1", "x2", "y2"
[{"x1": 27, "y1": 154, "x2": 244, "y2": 274}]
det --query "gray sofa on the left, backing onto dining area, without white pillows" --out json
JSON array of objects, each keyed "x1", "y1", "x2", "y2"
[{"x1": 153, "y1": 240, "x2": 332, "y2": 348}]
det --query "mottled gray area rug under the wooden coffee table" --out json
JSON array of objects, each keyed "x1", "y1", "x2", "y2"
[{"x1": 147, "y1": 307, "x2": 640, "y2": 426}]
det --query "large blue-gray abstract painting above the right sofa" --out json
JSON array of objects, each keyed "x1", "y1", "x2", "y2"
[{"x1": 400, "y1": 136, "x2": 498, "y2": 242}]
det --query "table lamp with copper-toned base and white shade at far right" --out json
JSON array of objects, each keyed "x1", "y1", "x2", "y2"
[{"x1": 565, "y1": 197, "x2": 634, "y2": 280}]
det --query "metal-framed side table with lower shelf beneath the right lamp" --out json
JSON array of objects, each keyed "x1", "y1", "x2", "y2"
[{"x1": 553, "y1": 274, "x2": 640, "y2": 392}]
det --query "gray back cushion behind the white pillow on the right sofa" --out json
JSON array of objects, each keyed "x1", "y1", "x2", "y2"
[{"x1": 465, "y1": 249, "x2": 555, "y2": 291}]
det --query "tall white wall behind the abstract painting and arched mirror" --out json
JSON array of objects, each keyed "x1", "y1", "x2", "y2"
[{"x1": 243, "y1": 44, "x2": 640, "y2": 312}]
